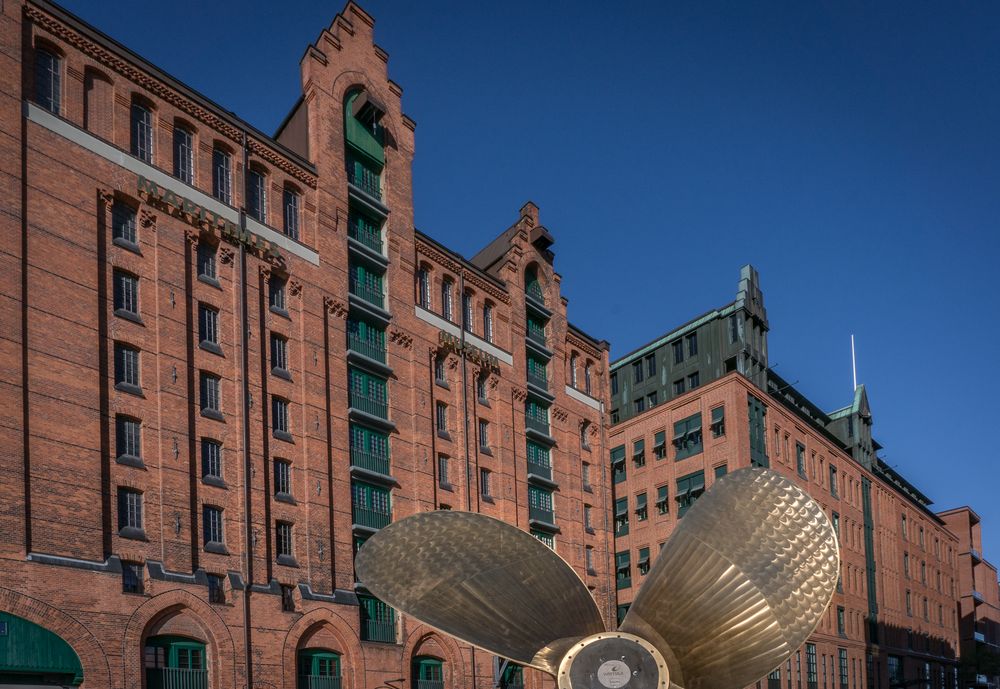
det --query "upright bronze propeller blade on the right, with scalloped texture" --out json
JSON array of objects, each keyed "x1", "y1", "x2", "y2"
[{"x1": 621, "y1": 469, "x2": 840, "y2": 689}]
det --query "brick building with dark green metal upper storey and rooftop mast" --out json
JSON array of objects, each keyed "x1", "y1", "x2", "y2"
[{"x1": 608, "y1": 266, "x2": 959, "y2": 689}]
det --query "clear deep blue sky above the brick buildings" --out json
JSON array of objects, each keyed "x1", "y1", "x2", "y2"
[{"x1": 63, "y1": 0, "x2": 1000, "y2": 564}]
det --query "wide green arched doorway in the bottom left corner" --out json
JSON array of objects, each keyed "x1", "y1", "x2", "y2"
[{"x1": 0, "y1": 612, "x2": 83, "y2": 687}]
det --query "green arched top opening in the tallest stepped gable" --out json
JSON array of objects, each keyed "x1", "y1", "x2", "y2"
[{"x1": 344, "y1": 90, "x2": 385, "y2": 201}]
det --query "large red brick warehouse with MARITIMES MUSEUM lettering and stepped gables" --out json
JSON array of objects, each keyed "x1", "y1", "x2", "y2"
[{"x1": 0, "y1": 0, "x2": 614, "y2": 689}]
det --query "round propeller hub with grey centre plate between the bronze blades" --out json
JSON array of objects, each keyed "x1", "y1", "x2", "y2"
[{"x1": 558, "y1": 632, "x2": 670, "y2": 689}]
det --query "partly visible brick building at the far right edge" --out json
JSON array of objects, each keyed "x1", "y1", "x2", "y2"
[{"x1": 938, "y1": 507, "x2": 1000, "y2": 689}]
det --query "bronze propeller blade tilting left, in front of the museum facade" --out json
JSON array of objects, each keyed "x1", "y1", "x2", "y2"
[{"x1": 355, "y1": 511, "x2": 604, "y2": 675}]
